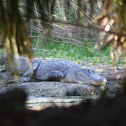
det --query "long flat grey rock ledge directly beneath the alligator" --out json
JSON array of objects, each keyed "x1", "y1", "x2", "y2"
[{"x1": 2, "y1": 82, "x2": 103, "y2": 97}]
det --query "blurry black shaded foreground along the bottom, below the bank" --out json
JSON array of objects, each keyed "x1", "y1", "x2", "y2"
[{"x1": 0, "y1": 80, "x2": 126, "y2": 126}]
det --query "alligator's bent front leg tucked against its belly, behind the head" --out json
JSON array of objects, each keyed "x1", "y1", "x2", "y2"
[{"x1": 37, "y1": 71, "x2": 63, "y2": 81}]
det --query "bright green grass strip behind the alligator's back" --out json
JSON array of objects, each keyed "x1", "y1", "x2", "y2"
[{"x1": 33, "y1": 38, "x2": 124, "y2": 65}]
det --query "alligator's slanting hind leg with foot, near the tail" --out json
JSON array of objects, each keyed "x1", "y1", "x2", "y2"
[{"x1": 21, "y1": 63, "x2": 39, "y2": 83}]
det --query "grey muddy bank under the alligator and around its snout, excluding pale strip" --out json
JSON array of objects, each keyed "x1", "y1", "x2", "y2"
[{"x1": 2, "y1": 61, "x2": 124, "y2": 97}]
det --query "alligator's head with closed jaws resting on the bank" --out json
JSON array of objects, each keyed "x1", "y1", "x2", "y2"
[{"x1": 65, "y1": 68, "x2": 107, "y2": 85}]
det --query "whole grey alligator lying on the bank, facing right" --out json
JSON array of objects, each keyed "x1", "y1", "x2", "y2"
[{"x1": 3, "y1": 56, "x2": 107, "y2": 85}]
